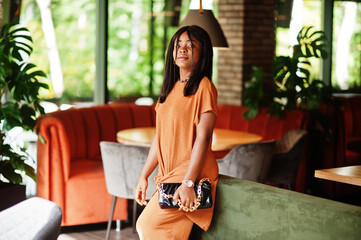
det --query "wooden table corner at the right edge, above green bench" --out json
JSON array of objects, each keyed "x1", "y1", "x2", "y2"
[{"x1": 315, "y1": 166, "x2": 361, "y2": 186}]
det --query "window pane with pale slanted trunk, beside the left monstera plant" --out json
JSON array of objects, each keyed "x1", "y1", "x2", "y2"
[{"x1": 20, "y1": 0, "x2": 96, "y2": 103}]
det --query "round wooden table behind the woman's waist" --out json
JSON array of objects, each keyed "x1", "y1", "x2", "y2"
[{"x1": 117, "y1": 127, "x2": 262, "y2": 151}]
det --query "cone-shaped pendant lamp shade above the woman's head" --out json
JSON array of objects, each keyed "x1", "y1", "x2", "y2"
[{"x1": 180, "y1": 9, "x2": 228, "y2": 48}]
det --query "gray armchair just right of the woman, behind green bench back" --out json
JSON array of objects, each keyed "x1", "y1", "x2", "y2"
[{"x1": 217, "y1": 141, "x2": 275, "y2": 183}]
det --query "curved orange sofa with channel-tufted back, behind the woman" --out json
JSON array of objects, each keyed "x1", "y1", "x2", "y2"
[{"x1": 37, "y1": 104, "x2": 305, "y2": 226}]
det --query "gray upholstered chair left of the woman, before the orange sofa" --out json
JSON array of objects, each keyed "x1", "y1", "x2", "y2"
[{"x1": 100, "y1": 141, "x2": 158, "y2": 239}]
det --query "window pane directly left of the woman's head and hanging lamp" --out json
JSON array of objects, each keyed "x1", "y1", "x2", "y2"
[{"x1": 108, "y1": 0, "x2": 197, "y2": 102}]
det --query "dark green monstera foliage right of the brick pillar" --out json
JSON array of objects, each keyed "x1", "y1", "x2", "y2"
[{"x1": 242, "y1": 27, "x2": 340, "y2": 138}]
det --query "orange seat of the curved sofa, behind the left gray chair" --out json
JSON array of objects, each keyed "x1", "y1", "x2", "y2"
[{"x1": 64, "y1": 159, "x2": 128, "y2": 225}]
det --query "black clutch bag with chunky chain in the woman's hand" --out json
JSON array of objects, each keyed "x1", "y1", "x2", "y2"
[{"x1": 157, "y1": 178, "x2": 212, "y2": 212}]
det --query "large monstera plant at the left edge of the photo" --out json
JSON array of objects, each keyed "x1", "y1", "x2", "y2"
[{"x1": 0, "y1": 23, "x2": 48, "y2": 183}]
